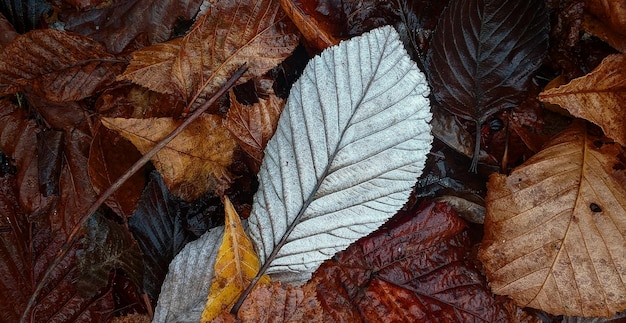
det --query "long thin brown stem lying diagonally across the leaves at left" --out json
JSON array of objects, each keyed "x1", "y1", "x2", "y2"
[{"x1": 20, "y1": 64, "x2": 248, "y2": 323}]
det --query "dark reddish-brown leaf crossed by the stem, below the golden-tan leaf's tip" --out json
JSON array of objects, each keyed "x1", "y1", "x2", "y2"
[{"x1": 89, "y1": 126, "x2": 146, "y2": 217}]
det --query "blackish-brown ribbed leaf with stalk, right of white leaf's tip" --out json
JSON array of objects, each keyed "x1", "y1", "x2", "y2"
[{"x1": 427, "y1": 0, "x2": 550, "y2": 170}]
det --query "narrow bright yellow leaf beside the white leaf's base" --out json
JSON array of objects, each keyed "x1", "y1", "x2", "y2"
[{"x1": 202, "y1": 197, "x2": 269, "y2": 322}]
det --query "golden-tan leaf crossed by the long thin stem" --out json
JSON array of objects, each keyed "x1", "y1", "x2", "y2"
[{"x1": 102, "y1": 115, "x2": 237, "y2": 201}]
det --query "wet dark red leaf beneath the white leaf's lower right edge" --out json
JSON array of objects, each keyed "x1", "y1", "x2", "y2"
[{"x1": 307, "y1": 203, "x2": 528, "y2": 322}]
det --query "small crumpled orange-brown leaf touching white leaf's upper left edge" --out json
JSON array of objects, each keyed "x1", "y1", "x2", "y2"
[{"x1": 224, "y1": 91, "x2": 285, "y2": 172}]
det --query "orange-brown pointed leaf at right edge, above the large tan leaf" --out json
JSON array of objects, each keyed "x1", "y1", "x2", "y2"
[{"x1": 539, "y1": 55, "x2": 626, "y2": 146}]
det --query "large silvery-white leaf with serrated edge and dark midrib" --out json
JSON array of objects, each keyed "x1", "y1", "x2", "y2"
[{"x1": 248, "y1": 26, "x2": 432, "y2": 283}]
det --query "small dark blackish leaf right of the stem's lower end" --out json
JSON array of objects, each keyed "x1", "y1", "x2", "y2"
[{"x1": 76, "y1": 213, "x2": 144, "y2": 298}]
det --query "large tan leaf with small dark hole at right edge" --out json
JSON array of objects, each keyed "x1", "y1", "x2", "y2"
[{"x1": 479, "y1": 122, "x2": 626, "y2": 316}]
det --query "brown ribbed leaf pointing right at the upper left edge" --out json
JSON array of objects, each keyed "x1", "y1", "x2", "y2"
[{"x1": 0, "y1": 29, "x2": 123, "y2": 102}]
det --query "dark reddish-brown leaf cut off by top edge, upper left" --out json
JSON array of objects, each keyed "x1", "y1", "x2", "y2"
[{"x1": 60, "y1": 0, "x2": 202, "y2": 54}]
